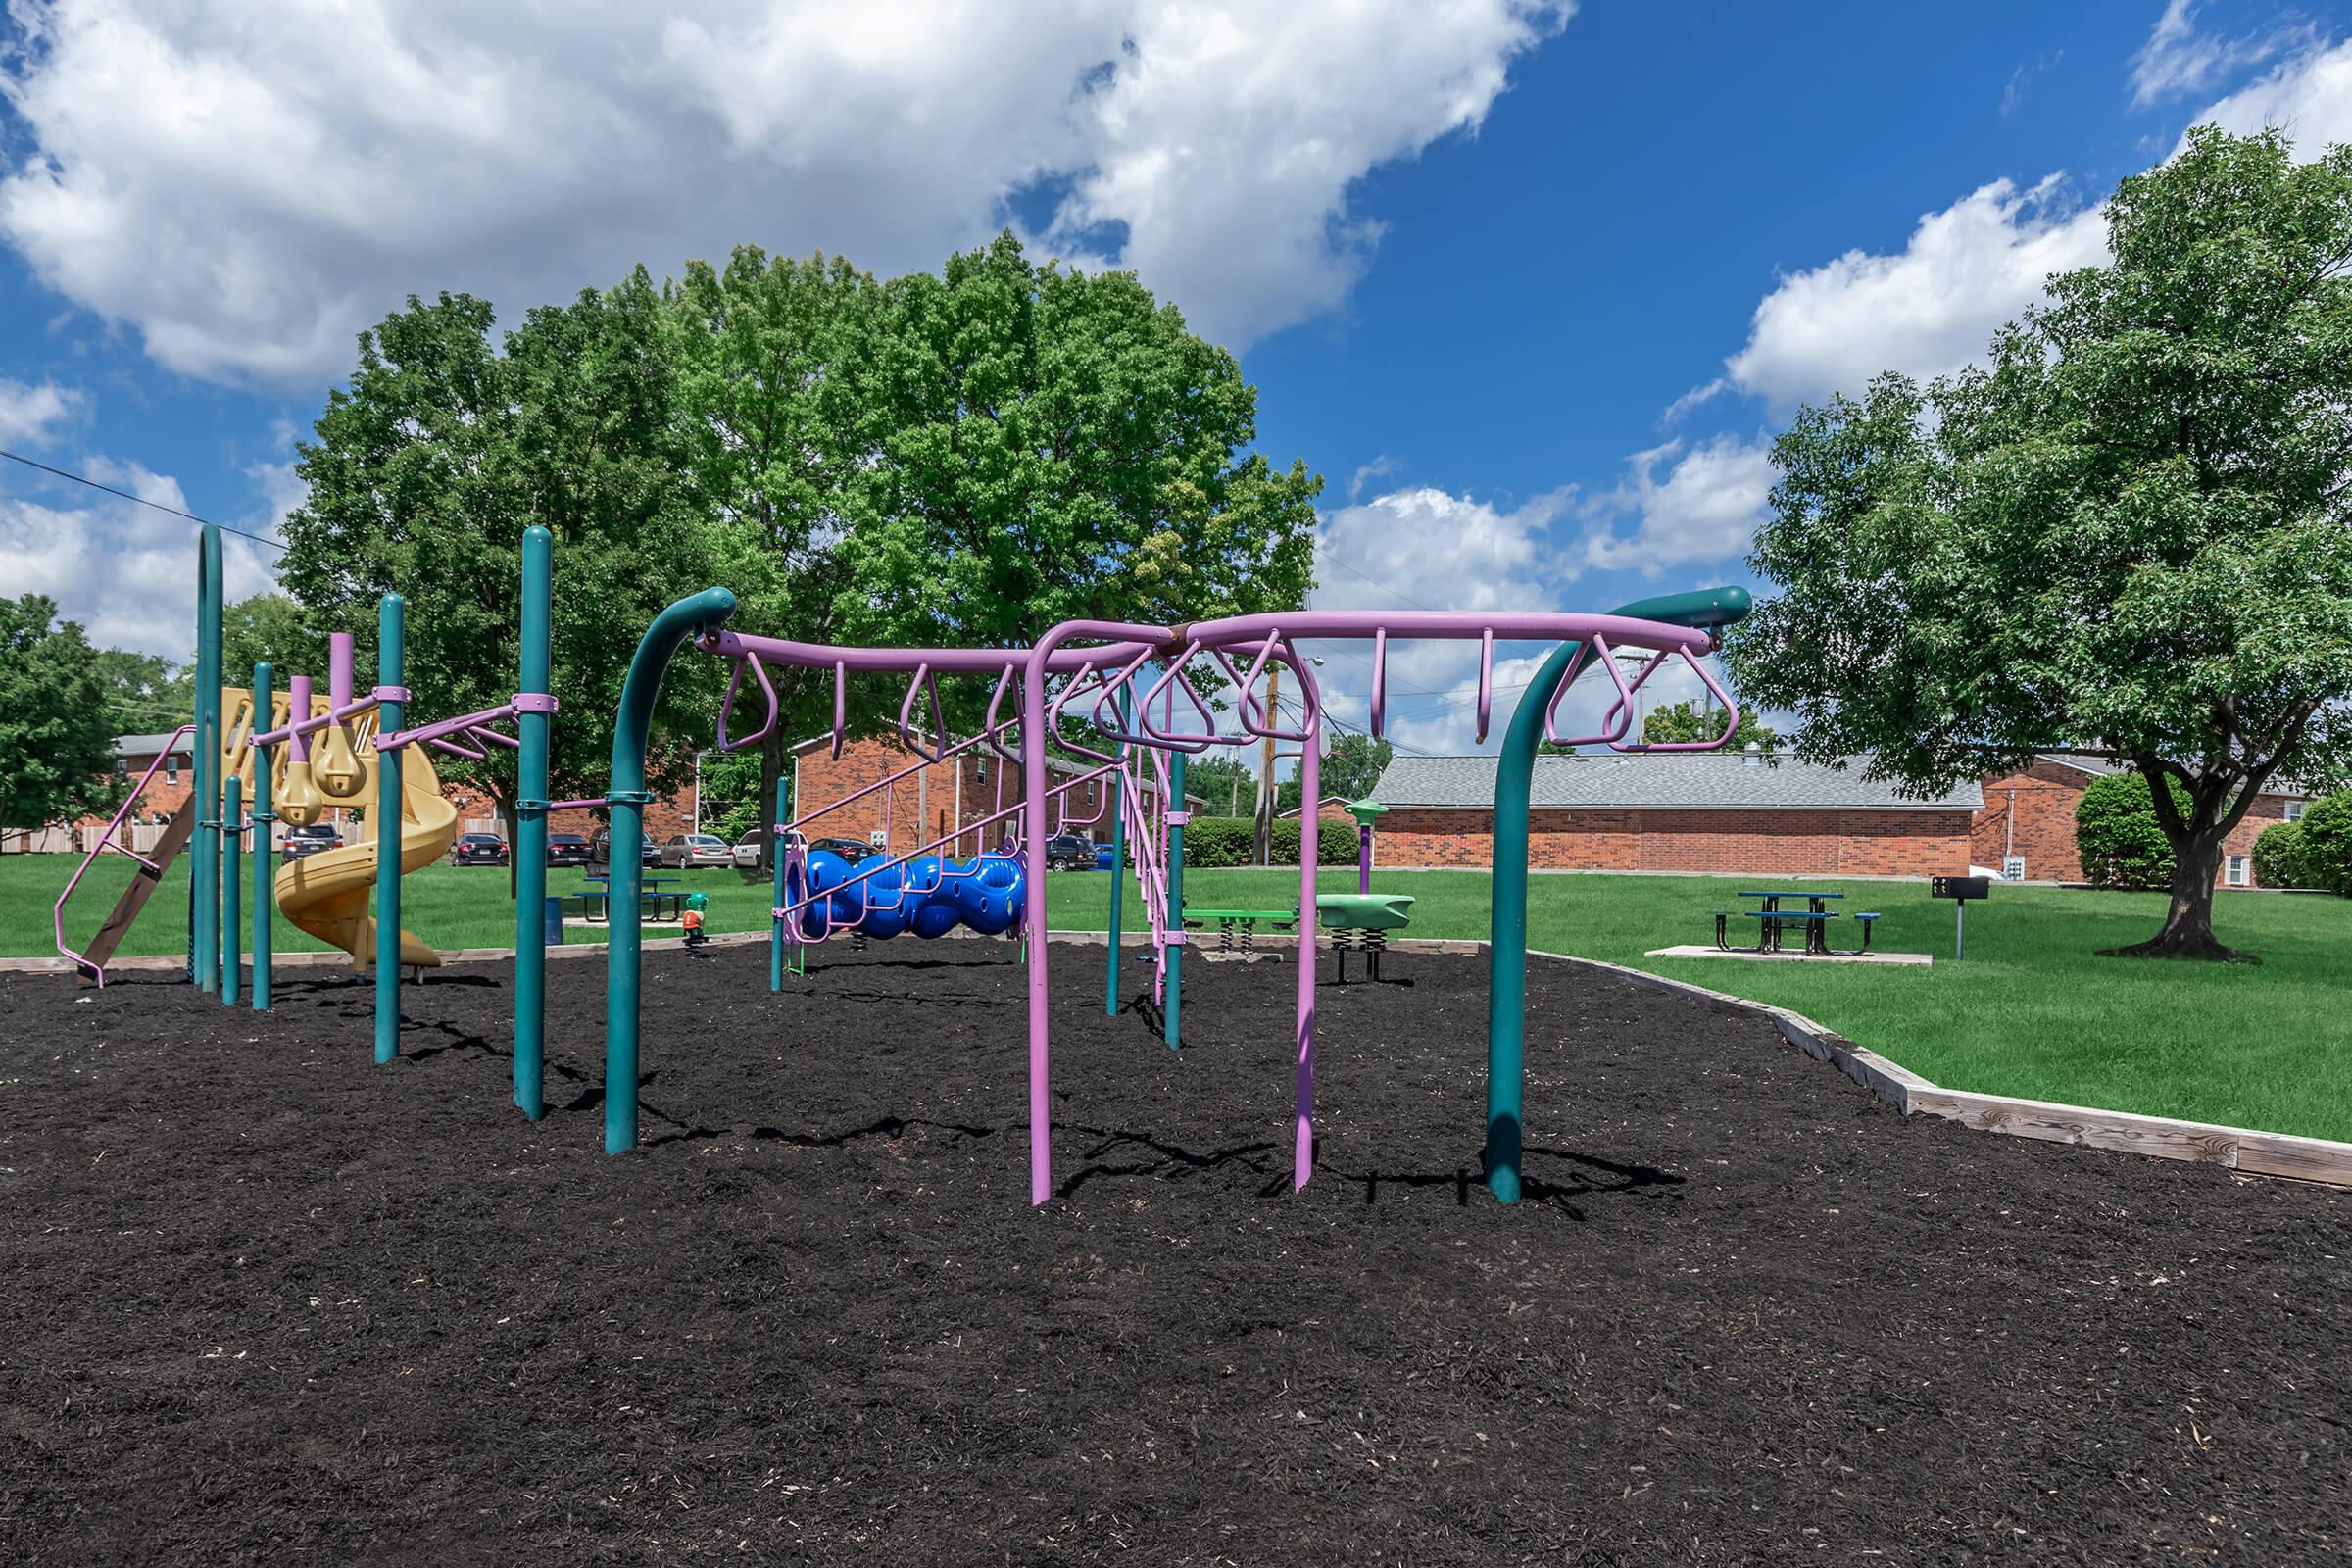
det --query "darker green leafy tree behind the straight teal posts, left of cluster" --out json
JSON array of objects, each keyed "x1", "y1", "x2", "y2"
[{"x1": 280, "y1": 270, "x2": 712, "y2": 851}]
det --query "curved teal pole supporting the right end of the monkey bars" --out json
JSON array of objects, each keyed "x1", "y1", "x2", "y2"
[{"x1": 1487, "y1": 588, "x2": 1747, "y2": 1203}]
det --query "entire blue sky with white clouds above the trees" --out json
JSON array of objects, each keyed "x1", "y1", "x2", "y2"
[{"x1": 0, "y1": 0, "x2": 2352, "y2": 750}]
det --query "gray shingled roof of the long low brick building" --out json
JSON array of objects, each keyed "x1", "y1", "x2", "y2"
[{"x1": 1371, "y1": 753, "x2": 1985, "y2": 811}]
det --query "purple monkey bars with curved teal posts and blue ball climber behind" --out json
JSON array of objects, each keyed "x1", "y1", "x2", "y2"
[{"x1": 605, "y1": 588, "x2": 1747, "y2": 1203}]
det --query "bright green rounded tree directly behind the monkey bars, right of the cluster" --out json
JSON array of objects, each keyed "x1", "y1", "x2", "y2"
[{"x1": 835, "y1": 232, "x2": 1322, "y2": 649}]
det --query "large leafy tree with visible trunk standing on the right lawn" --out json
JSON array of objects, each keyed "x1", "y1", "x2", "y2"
[{"x1": 1729, "y1": 129, "x2": 2352, "y2": 959}]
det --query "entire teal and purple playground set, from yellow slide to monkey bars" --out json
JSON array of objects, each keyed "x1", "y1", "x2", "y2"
[{"x1": 86, "y1": 526, "x2": 1747, "y2": 1203}]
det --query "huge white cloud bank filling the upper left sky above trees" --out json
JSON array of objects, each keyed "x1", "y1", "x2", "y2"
[{"x1": 0, "y1": 0, "x2": 1571, "y2": 383}]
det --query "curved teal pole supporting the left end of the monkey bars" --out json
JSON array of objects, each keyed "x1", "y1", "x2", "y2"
[{"x1": 605, "y1": 588, "x2": 734, "y2": 1154}]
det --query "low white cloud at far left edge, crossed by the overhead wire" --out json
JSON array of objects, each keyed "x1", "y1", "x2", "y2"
[{"x1": 0, "y1": 456, "x2": 275, "y2": 662}]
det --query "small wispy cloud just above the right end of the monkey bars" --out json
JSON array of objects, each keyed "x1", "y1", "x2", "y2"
[{"x1": 1578, "y1": 435, "x2": 1774, "y2": 576}]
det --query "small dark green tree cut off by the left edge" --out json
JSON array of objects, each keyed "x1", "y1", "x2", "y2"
[{"x1": 0, "y1": 592, "x2": 120, "y2": 832}]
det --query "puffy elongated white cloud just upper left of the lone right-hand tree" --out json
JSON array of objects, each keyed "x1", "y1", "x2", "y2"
[{"x1": 1724, "y1": 174, "x2": 2107, "y2": 407}]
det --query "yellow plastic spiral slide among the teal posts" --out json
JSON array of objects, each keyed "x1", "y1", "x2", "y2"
[{"x1": 277, "y1": 724, "x2": 457, "y2": 968}]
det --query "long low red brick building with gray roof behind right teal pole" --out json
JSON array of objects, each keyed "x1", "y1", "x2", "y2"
[{"x1": 1374, "y1": 753, "x2": 1983, "y2": 877}]
